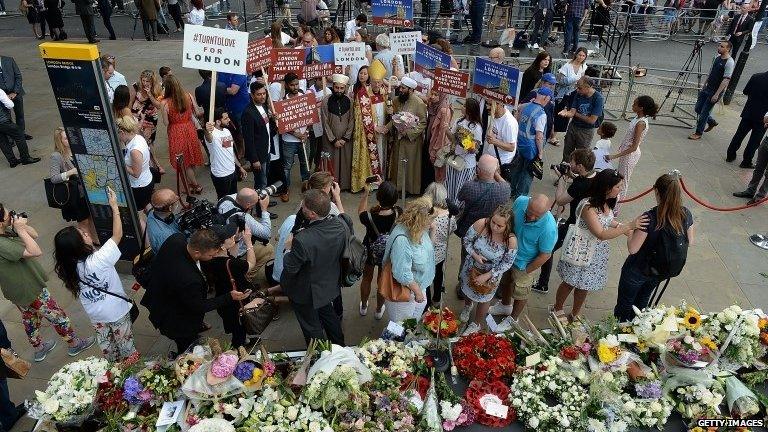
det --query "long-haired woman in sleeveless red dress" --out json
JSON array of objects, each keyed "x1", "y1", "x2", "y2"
[{"x1": 163, "y1": 75, "x2": 203, "y2": 194}]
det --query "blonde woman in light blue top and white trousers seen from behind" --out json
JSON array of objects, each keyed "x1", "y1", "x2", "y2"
[{"x1": 384, "y1": 197, "x2": 435, "y2": 322}]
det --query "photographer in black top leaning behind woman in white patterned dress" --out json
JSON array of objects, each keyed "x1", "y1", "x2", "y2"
[{"x1": 532, "y1": 149, "x2": 595, "y2": 294}]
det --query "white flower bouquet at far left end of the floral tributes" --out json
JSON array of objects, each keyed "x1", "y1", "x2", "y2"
[{"x1": 29, "y1": 357, "x2": 109, "y2": 425}]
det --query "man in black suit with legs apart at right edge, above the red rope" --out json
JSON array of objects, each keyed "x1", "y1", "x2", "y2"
[{"x1": 725, "y1": 72, "x2": 768, "y2": 168}]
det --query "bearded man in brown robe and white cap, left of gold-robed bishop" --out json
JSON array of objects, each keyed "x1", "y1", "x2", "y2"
[{"x1": 321, "y1": 74, "x2": 355, "y2": 190}]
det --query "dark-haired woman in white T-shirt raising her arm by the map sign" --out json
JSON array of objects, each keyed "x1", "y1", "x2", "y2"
[{"x1": 53, "y1": 188, "x2": 136, "y2": 362}]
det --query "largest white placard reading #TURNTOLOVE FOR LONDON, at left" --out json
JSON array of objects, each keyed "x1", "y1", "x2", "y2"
[{"x1": 181, "y1": 24, "x2": 248, "y2": 75}]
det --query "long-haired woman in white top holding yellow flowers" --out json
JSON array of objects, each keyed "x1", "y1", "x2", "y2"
[{"x1": 445, "y1": 98, "x2": 483, "y2": 201}]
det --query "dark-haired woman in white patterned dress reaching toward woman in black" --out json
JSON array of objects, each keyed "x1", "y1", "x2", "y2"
[{"x1": 554, "y1": 169, "x2": 648, "y2": 322}]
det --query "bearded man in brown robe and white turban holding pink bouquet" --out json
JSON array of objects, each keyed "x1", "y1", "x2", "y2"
[{"x1": 385, "y1": 77, "x2": 427, "y2": 195}]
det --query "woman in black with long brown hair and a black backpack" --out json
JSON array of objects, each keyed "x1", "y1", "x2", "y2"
[{"x1": 613, "y1": 174, "x2": 694, "y2": 321}]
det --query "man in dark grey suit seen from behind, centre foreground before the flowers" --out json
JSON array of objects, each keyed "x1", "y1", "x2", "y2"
[{"x1": 280, "y1": 189, "x2": 352, "y2": 346}]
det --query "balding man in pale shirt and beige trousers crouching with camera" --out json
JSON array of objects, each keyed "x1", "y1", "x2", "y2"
[{"x1": 216, "y1": 188, "x2": 275, "y2": 287}]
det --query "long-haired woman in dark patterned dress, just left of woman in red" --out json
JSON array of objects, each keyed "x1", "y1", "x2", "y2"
[{"x1": 129, "y1": 69, "x2": 165, "y2": 174}]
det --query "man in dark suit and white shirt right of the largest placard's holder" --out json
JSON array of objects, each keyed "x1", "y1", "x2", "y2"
[{"x1": 240, "y1": 81, "x2": 277, "y2": 189}]
